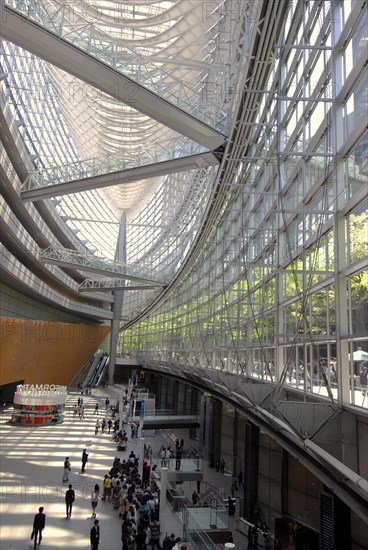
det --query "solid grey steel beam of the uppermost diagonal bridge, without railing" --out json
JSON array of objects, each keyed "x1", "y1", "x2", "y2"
[{"x1": 0, "y1": 4, "x2": 225, "y2": 150}]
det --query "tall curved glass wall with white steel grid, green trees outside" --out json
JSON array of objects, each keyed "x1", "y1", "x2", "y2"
[{"x1": 121, "y1": 1, "x2": 368, "y2": 407}]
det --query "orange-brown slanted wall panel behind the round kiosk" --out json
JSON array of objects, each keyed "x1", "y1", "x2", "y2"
[{"x1": 0, "y1": 318, "x2": 110, "y2": 385}]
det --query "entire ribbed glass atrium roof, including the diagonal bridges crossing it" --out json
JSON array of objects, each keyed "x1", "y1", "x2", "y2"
[{"x1": 1, "y1": 0, "x2": 251, "y2": 319}]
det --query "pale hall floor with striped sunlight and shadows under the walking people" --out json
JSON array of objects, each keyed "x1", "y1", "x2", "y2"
[{"x1": 0, "y1": 387, "x2": 247, "y2": 550}]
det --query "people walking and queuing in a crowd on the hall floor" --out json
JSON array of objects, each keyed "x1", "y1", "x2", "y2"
[{"x1": 35, "y1": 391, "x2": 187, "y2": 550}]
